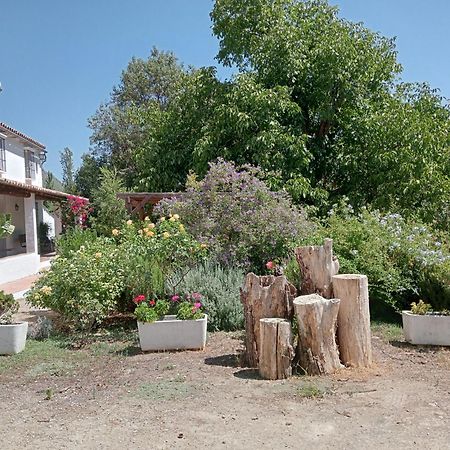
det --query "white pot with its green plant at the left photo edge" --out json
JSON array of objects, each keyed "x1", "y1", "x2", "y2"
[{"x1": 0, "y1": 291, "x2": 28, "y2": 355}]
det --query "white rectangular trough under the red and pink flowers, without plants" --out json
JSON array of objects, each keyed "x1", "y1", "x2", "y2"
[{"x1": 138, "y1": 314, "x2": 208, "y2": 351}]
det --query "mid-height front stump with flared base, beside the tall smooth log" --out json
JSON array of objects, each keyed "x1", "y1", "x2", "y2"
[{"x1": 294, "y1": 294, "x2": 342, "y2": 375}]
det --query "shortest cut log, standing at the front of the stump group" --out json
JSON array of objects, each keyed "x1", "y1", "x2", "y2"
[{"x1": 259, "y1": 319, "x2": 294, "y2": 380}]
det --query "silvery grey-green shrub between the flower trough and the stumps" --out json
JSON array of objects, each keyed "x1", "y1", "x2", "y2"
[{"x1": 173, "y1": 263, "x2": 244, "y2": 331}]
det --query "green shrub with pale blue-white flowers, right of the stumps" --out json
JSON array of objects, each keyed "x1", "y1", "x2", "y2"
[{"x1": 309, "y1": 206, "x2": 450, "y2": 312}]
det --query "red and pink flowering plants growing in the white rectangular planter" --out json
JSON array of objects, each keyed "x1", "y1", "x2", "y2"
[{"x1": 133, "y1": 292, "x2": 204, "y2": 322}]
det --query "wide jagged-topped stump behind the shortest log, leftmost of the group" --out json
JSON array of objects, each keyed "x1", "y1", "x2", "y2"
[{"x1": 241, "y1": 273, "x2": 297, "y2": 367}]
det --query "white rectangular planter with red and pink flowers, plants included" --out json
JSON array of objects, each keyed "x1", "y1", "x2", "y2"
[{"x1": 133, "y1": 292, "x2": 208, "y2": 351}]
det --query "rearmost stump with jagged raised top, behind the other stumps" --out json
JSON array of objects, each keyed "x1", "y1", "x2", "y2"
[{"x1": 295, "y1": 239, "x2": 339, "y2": 298}]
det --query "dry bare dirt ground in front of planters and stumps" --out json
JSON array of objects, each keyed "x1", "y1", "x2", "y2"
[{"x1": 0, "y1": 326, "x2": 450, "y2": 450}]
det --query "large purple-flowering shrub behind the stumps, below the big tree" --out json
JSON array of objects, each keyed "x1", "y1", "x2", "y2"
[{"x1": 155, "y1": 159, "x2": 311, "y2": 273}]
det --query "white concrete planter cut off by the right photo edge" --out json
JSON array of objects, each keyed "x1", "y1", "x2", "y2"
[{"x1": 402, "y1": 311, "x2": 450, "y2": 345}]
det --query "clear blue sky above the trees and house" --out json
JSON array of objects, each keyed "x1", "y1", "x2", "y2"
[{"x1": 0, "y1": 0, "x2": 450, "y2": 179}]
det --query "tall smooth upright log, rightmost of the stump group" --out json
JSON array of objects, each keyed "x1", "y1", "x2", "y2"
[{"x1": 333, "y1": 274, "x2": 372, "y2": 367}]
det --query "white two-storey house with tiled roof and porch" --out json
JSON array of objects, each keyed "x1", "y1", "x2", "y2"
[{"x1": 0, "y1": 122, "x2": 67, "y2": 284}]
